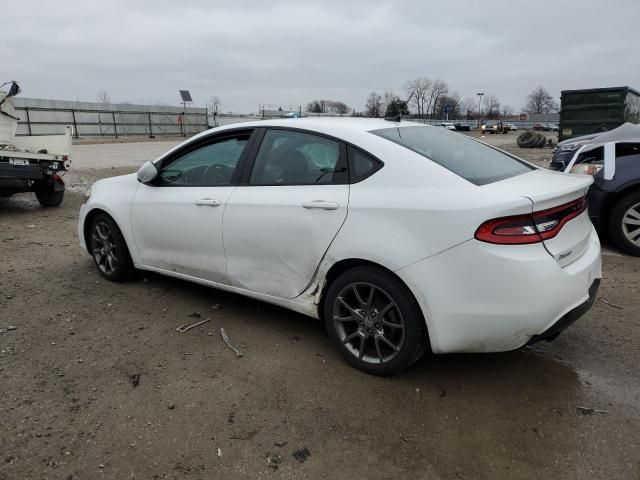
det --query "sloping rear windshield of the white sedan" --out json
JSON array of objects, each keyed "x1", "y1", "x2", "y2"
[{"x1": 371, "y1": 127, "x2": 534, "y2": 185}]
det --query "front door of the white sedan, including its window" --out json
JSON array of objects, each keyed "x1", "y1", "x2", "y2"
[{"x1": 131, "y1": 131, "x2": 252, "y2": 283}]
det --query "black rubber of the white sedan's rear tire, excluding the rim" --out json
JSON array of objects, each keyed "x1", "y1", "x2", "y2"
[{"x1": 323, "y1": 266, "x2": 427, "y2": 376}]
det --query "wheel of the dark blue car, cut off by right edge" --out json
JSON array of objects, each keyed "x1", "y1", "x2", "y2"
[{"x1": 609, "y1": 191, "x2": 640, "y2": 257}]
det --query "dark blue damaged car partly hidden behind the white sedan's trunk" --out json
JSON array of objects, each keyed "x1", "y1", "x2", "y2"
[{"x1": 551, "y1": 123, "x2": 640, "y2": 256}]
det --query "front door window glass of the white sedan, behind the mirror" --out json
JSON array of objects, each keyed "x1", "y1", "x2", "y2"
[{"x1": 157, "y1": 133, "x2": 250, "y2": 187}]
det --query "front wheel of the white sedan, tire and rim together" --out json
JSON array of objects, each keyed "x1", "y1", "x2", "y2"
[{"x1": 89, "y1": 214, "x2": 134, "y2": 282}]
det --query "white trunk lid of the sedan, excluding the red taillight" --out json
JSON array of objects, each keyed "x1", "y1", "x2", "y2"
[{"x1": 488, "y1": 169, "x2": 593, "y2": 267}]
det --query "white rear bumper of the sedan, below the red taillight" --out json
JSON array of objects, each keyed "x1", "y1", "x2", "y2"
[{"x1": 396, "y1": 227, "x2": 602, "y2": 353}]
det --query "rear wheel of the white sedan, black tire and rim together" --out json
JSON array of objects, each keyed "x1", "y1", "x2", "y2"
[{"x1": 323, "y1": 266, "x2": 429, "y2": 376}]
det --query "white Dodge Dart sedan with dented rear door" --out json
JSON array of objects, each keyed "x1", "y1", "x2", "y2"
[{"x1": 78, "y1": 118, "x2": 601, "y2": 375}]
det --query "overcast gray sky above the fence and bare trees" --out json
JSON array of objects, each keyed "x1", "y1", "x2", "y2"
[{"x1": 5, "y1": 0, "x2": 640, "y2": 112}]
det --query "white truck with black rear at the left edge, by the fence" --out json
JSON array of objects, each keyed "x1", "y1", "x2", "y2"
[{"x1": 0, "y1": 81, "x2": 72, "y2": 207}]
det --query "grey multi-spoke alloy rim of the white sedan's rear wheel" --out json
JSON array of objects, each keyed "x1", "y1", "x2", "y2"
[{"x1": 333, "y1": 282, "x2": 405, "y2": 364}]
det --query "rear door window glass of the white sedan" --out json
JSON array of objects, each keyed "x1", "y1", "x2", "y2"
[{"x1": 249, "y1": 130, "x2": 345, "y2": 185}]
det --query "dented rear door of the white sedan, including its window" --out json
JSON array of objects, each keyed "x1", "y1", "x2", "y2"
[{"x1": 224, "y1": 128, "x2": 349, "y2": 298}]
